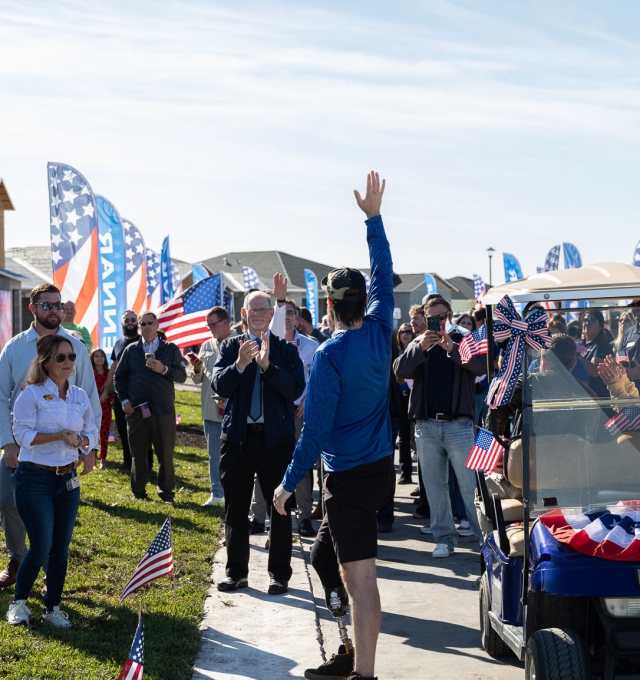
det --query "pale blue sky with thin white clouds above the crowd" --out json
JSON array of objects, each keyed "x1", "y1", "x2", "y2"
[{"x1": 0, "y1": 0, "x2": 640, "y2": 282}]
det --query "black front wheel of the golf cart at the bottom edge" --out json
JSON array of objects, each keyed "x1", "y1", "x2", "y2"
[{"x1": 525, "y1": 628, "x2": 591, "y2": 680}]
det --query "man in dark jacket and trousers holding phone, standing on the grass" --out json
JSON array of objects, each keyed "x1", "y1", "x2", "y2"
[{"x1": 115, "y1": 312, "x2": 187, "y2": 503}]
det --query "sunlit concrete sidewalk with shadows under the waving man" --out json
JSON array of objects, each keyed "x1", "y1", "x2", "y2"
[{"x1": 193, "y1": 484, "x2": 524, "y2": 680}]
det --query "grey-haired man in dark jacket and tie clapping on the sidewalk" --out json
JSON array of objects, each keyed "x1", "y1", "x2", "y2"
[{"x1": 212, "y1": 292, "x2": 305, "y2": 595}]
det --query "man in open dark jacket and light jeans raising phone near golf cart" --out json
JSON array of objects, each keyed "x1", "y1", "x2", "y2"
[{"x1": 394, "y1": 298, "x2": 487, "y2": 558}]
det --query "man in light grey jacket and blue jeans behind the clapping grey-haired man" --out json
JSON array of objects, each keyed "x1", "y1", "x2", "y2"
[{"x1": 187, "y1": 307, "x2": 236, "y2": 505}]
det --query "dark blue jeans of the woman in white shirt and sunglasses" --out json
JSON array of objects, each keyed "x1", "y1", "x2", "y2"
[{"x1": 13, "y1": 463, "x2": 80, "y2": 611}]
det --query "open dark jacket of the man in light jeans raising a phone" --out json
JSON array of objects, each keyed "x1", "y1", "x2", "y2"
[{"x1": 393, "y1": 332, "x2": 487, "y2": 420}]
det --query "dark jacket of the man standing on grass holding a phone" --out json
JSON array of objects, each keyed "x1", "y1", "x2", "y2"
[{"x1": 115, "y1": 338, "x2": 187, "y2": 416}]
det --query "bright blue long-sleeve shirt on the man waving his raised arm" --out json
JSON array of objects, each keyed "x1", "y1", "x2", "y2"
[{"x1": 282, "y1": 216, "x2": 393, "y2": 491}]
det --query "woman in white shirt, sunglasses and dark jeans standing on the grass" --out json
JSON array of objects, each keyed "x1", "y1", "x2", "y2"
[{"x1": 7, "y1": 334, "x2": 98, "y2": 628}]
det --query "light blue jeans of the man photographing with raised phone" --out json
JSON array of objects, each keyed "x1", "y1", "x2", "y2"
[{"x1": 416, "y1": 418, "x2": 482, "y2": 548}]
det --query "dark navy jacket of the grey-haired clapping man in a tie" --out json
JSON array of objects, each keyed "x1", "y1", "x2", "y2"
[{"x1": 211, "y1": 333, "x2": 305, "y2": 448}]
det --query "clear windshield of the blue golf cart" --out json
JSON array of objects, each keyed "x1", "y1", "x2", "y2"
[{"x1": 523, "y1": 300, "x2": 640, "y2": 513}]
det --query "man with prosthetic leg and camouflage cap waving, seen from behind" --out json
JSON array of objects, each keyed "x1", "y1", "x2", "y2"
[{"x1": 274, "y1": 172, "x2": 395, "y2": 678}]
